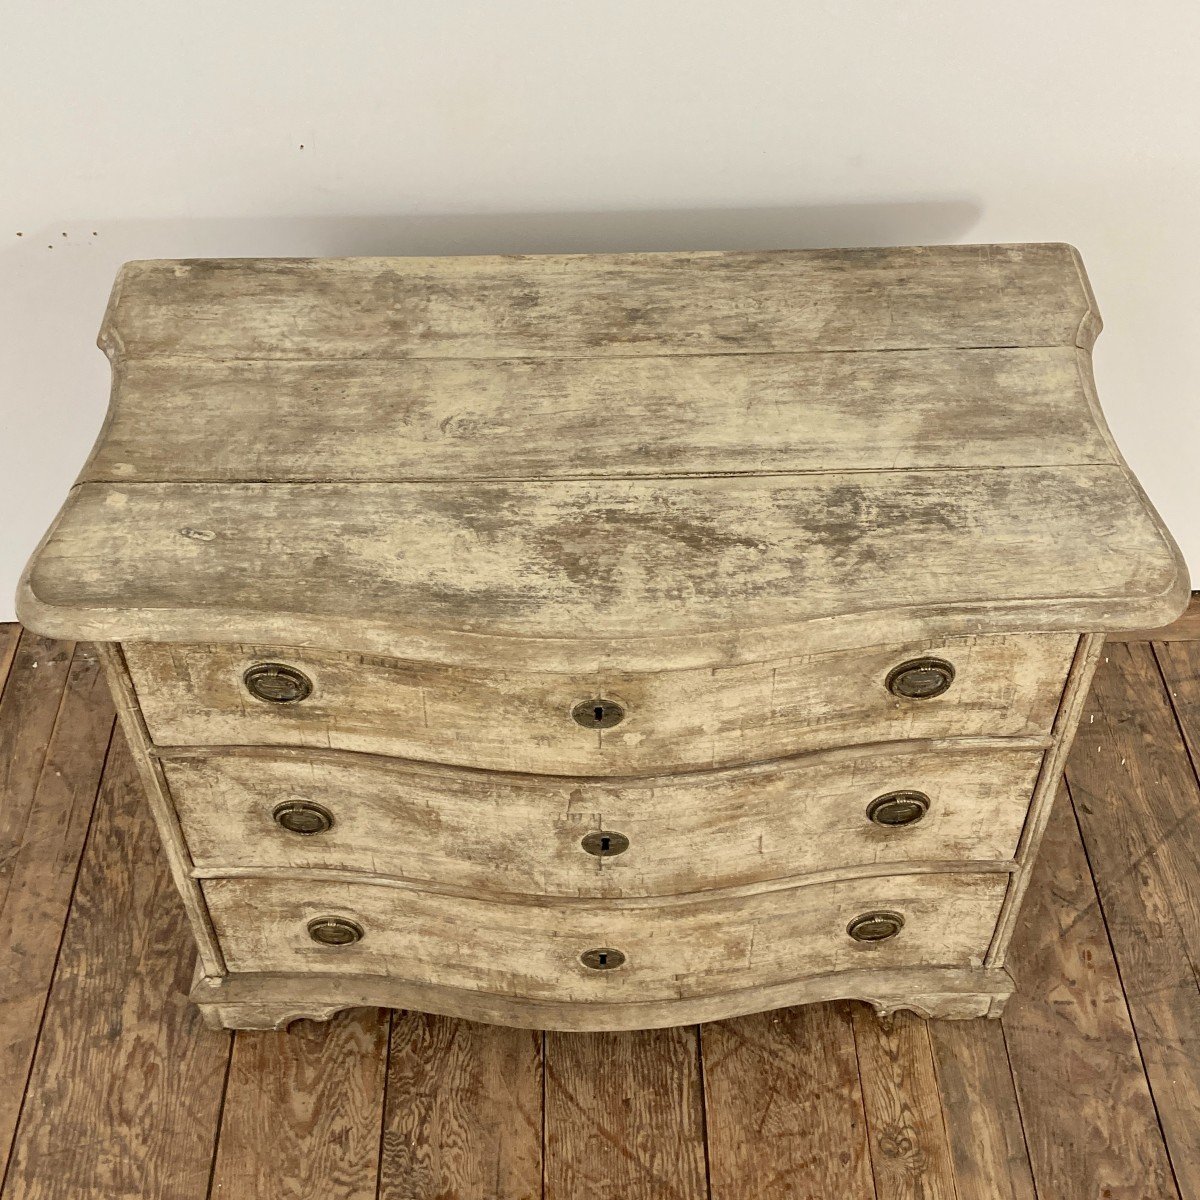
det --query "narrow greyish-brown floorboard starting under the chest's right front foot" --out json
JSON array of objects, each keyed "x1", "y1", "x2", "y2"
[{"x1": 929, "y1": 1020, "x2": 1034, "y2": 1200}]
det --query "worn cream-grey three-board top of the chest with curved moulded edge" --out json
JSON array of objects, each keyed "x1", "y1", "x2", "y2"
[{"x1": 19, "y1": 245, "x2": 1188, "y2": 671}]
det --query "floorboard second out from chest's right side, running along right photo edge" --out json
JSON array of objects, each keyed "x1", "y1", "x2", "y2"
[{"x1": 1067, "y1": 642, "x2": 1200, "y2": 1195}]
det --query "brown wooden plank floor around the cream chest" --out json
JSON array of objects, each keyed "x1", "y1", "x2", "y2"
[{"x1": 0, "y1": 625, "x2": 1200, "y2": 1200}]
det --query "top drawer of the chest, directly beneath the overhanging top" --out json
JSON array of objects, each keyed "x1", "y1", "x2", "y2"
[{"x1": 125, "y1": 634, "x2": 1076, "y2": 775}]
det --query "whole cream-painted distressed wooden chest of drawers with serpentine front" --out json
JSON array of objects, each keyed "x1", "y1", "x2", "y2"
[{"x1": 18, "y1": 245, "x2": 1188, "y2": 1030}]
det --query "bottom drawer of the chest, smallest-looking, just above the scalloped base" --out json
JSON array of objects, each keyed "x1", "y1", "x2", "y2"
[{"x1": 203, "y1": 872, "x2": 1008, "y2": 1002}]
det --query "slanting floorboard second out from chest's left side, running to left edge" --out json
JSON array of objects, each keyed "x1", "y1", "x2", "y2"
[{"x1": 0, "y1": 646, "x2": 115, "y2": 1176}]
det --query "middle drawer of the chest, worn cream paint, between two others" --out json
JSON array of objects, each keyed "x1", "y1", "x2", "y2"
[{"x1": 163, "y1": 745, "x2": 1042, "y2": 898}]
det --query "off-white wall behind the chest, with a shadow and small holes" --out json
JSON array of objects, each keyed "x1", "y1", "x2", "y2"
[{"x1": 0, "y1": 0, "x2": 1200, "y2": 619}]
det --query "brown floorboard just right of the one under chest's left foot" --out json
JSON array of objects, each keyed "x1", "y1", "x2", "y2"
[{"x1": 379, "y1": 1012, "x2": 542, "y2": 1200}]
